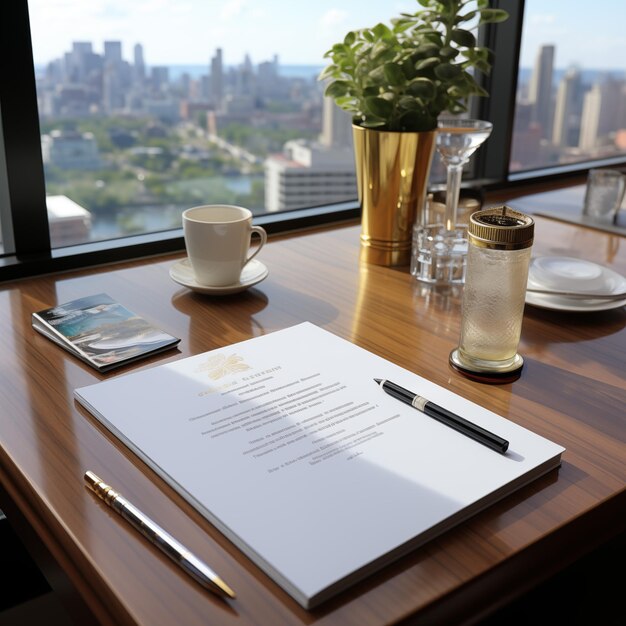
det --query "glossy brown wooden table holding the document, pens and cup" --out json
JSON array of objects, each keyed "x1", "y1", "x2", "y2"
[{"x1": 0, "y1": 213, "x2": 626, "y2": 626}]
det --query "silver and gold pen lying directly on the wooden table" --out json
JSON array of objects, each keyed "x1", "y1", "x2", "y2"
[{"x1": 85, "y1": 471, "x2": 235, "y2": 598}]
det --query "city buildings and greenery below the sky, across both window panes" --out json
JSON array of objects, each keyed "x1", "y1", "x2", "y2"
[{"x1": 31, "y1": 12, "x2": 626, "y2": 238}]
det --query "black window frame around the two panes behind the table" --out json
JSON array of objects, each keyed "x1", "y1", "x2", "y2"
[{"x1": 0, "y1": 0, "x2": 626, "y2": 282}]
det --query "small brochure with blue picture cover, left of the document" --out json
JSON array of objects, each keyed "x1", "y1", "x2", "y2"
[{"x1": 32, "y1": 293, "x2": 180, "y2": 372}]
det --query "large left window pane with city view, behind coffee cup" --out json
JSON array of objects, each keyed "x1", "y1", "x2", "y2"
[{"x1": 28, "y1": 0, "x2": 428, "y2": 248}]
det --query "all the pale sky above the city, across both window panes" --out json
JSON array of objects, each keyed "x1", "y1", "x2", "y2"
[{"x1": 28, "y1": 0, "x2": 626, "y2": 70}]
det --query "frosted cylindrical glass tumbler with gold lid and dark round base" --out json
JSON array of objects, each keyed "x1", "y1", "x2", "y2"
[{"x1": 450, "y1": 206, "x2": 534, "y2": 382}]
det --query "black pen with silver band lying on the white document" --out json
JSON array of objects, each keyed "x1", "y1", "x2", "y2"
[{"x1": 374, "y1": 378, "x2": 509, "y2": 454}]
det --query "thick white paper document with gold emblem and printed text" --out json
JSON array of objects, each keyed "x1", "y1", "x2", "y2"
[{"x1": 75, "y1": 322, "x2": 564, "y2": 608}]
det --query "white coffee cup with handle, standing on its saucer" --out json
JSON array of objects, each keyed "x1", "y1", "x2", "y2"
[{"x1": 183, "y1": 204, "x2": 267, "y2": 287}]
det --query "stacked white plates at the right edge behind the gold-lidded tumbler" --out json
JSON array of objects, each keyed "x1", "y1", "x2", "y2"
[{"x1": 526, "y1": 256, "x2": 626, "y2": 311}]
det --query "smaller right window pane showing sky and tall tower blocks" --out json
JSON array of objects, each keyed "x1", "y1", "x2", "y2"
[{"x1": 510, "y1": 0, "x2": 626, "y2": 172}]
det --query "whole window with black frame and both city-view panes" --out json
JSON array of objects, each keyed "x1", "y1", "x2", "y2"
[{"x1": 0, "y1": 0, "x2": 626, "y2": 280}]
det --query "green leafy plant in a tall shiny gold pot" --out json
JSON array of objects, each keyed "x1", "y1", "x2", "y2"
[{"x1": 319, "y1": 0, "x2": 508, "y2": 265}]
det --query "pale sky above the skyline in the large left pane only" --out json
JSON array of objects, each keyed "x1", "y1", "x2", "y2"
[{"x1": 30, "y1": 0, "x2": 419, "y2": 65}]
